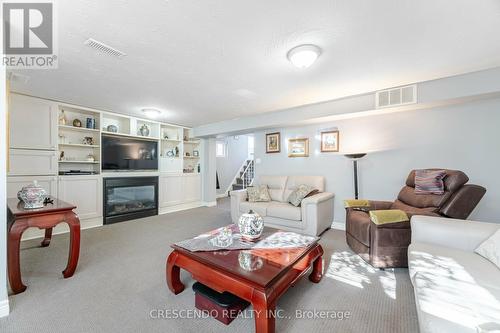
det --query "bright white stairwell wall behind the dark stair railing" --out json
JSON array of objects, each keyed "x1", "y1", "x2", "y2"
[{"x1": 216, "y1": 135, "x2": 248, "y2": 194}]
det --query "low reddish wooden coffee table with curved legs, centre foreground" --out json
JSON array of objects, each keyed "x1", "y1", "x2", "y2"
[{"x1": 166, "y1": 228, "x2": 323, "y2": 333}]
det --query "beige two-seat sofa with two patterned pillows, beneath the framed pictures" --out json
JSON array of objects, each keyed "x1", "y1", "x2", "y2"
[{"x1": 230, "y1": 176, "x2": 334, "y2": 236}]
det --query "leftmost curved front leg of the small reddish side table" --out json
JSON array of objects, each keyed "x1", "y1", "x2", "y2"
[{"x1": 7, "y1": 220, "x2": 28, "y2": 294}]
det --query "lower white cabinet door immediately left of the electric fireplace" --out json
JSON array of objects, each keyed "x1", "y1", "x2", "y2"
[{"x1": 58, "y1": 175, "x2": 102, "y2": 220}]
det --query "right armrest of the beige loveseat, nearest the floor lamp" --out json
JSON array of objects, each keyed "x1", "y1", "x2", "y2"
[{"x1": 301, "y1": 192, "x2": 335, "y2": 236}]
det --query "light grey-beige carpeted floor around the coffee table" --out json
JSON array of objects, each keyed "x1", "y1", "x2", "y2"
[{"x1": 0, "y1": 202, "x2": 418, "y2": 333}]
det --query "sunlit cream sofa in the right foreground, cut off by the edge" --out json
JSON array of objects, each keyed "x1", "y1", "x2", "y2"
[{"x1": 408, "y1": 216, "x2": 500, "y2": 333}]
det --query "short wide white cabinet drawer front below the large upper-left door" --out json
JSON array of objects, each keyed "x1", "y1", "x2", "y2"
[{"x1": 9, "y1": 149, "x2": 57, "y2": 176}]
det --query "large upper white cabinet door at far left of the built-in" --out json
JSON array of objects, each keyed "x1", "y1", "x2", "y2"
[{"x1": 9, "y1": 94, "x2": 57, "y2": 150}]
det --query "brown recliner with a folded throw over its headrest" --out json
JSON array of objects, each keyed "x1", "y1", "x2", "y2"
[{"x1": 346, "y1": 169, "x2": 486, "y2": 268}]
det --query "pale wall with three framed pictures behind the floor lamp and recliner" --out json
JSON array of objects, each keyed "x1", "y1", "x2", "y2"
[{"x1": 255, "y1": 98, "x2": 500, "y2": 223}]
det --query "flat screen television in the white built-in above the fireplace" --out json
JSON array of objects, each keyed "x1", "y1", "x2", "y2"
[{"x1": 101, "y1": 135, "x2": 158, "y2": 170}]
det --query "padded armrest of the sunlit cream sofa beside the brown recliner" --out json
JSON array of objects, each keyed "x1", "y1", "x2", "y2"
[{"x1": 411, "y1": 215, "x2": 500, "y2": 252}]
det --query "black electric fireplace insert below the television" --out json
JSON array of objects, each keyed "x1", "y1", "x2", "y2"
[{"x1": 104, "y1": 177, "x2": 158, "y2": 224}]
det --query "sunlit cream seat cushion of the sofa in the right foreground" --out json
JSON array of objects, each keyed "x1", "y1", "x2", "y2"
[{"x1": 408, "y1": 243, "x2": 500, "y2": 332}]
